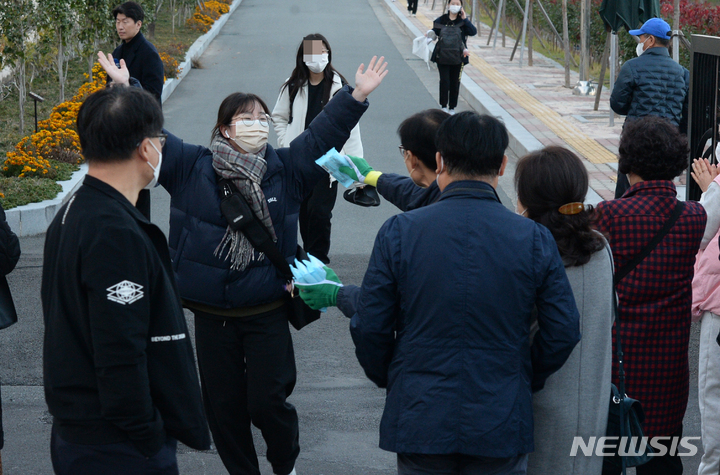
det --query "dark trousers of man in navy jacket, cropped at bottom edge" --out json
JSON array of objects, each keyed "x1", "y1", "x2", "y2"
[{"x1": 398, "y1": 454, "x2": 528, "y2": 475}]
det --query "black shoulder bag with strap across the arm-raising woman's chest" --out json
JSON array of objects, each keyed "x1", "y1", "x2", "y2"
[{"x1": 218, "y1": 177, "x2": 320, "y2": 330}]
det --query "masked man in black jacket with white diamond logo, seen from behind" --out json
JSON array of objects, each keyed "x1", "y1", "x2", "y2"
[{"x1": 41, "y1": 86, "x2": 210, "y2": 475}]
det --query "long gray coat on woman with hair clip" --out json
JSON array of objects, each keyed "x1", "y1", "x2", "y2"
[{"x1": 527, "y1": 244, "x2": 613, "y2": 475}]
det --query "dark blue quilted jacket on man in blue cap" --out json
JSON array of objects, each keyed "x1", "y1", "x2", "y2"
[{"x1": 610, "y1": 47, "x2": 690, "y2": 131}]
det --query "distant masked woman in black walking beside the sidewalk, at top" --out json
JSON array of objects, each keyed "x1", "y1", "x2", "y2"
[{"x1": 428, "y1": 0, "x2": 477, "y2": 114}]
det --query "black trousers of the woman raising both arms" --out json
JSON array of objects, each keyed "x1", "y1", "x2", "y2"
[{"x1": 193, "y1": 306, "x2": 300, "y2": 475}]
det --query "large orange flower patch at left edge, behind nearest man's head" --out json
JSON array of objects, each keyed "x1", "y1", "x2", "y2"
[{"x1": 2, "y1": 63, "x2": 106, "y2": 178}]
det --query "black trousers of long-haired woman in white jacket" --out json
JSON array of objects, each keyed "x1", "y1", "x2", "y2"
[{"x1": 300, "y1": 175, "x2": 337, "y2": 264}]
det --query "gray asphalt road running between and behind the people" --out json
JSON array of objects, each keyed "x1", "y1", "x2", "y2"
[{"x1": 0, "y1": 0, "x2": 699, "y2": 475}]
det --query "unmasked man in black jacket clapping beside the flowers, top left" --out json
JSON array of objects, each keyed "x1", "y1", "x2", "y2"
[{"x1": 113, "y1": 2, "x2": 165, "y2": 104}]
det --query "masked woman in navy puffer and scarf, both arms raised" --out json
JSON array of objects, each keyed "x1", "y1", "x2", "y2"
[{"x1": 96, "y1": 51, "x2": 387, "y2": 475}]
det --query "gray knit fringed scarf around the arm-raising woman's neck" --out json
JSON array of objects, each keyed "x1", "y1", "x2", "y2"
[{"x1": 210, "y1": 137, "x2": 277, "y2": 271}]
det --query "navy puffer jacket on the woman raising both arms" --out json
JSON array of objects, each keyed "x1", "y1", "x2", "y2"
[{"x1": 159, "y1": 86, "x2": 368, "y2": 309}]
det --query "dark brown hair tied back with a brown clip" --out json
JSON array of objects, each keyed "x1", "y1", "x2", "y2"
[{"x1": 515, "y1": 146, "x2": 605, "y2": 267}]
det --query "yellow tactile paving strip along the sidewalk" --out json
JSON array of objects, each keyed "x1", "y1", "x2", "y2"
[{"x1": 416, "y1": 16, "x2": 617, "y2": 163}]
